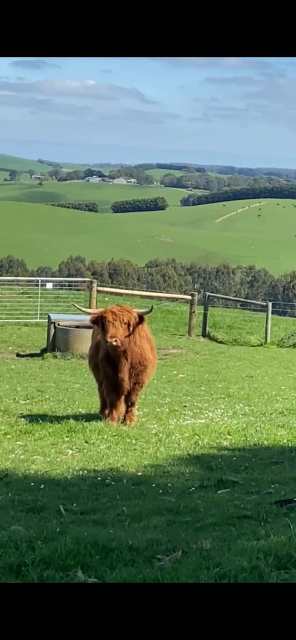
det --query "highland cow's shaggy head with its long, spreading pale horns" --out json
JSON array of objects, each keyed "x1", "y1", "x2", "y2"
[{"x1": 74, "y1": 304, "x2": 153, "y2": 351}]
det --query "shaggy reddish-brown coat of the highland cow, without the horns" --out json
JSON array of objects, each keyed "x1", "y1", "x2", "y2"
[{"x1": 88, "y1": 305, "x2": 157, "y2": 424}]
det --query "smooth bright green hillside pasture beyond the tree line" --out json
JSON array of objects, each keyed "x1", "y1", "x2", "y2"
[{"x1": 0, "y1": 183, "x2": 296, "y2": 274}]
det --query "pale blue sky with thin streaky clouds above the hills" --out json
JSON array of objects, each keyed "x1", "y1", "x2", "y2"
[{"x1": 0, "y1": 57, "x2": 296, "y2": 168}]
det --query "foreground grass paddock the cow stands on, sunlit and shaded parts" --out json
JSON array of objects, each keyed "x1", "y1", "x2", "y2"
[{"x1": 0, "y1": 298, "x2": 296, "y2": 582}]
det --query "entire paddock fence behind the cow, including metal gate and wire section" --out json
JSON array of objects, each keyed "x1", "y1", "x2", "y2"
[{"x1": 0, "y1": 277, "x2": 296, "y2": 346}]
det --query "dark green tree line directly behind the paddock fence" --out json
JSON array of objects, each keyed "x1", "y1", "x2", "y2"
[{"x1": 0, "y1": 255, "x2": 296, "y2": 302}]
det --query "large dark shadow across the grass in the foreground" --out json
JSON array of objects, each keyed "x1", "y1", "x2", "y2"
[{"x1": 0, "y1": 442, "x2": 296, "y2": 582}]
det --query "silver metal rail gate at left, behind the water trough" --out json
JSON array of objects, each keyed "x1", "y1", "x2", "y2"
[{"x1": 0, "y1": 277, "x2": 91, "y2": 323}]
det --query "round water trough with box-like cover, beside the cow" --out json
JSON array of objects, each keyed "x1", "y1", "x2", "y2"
[{"x1": 47, "y1": 313, "x2": 93, "y2": 354}]
